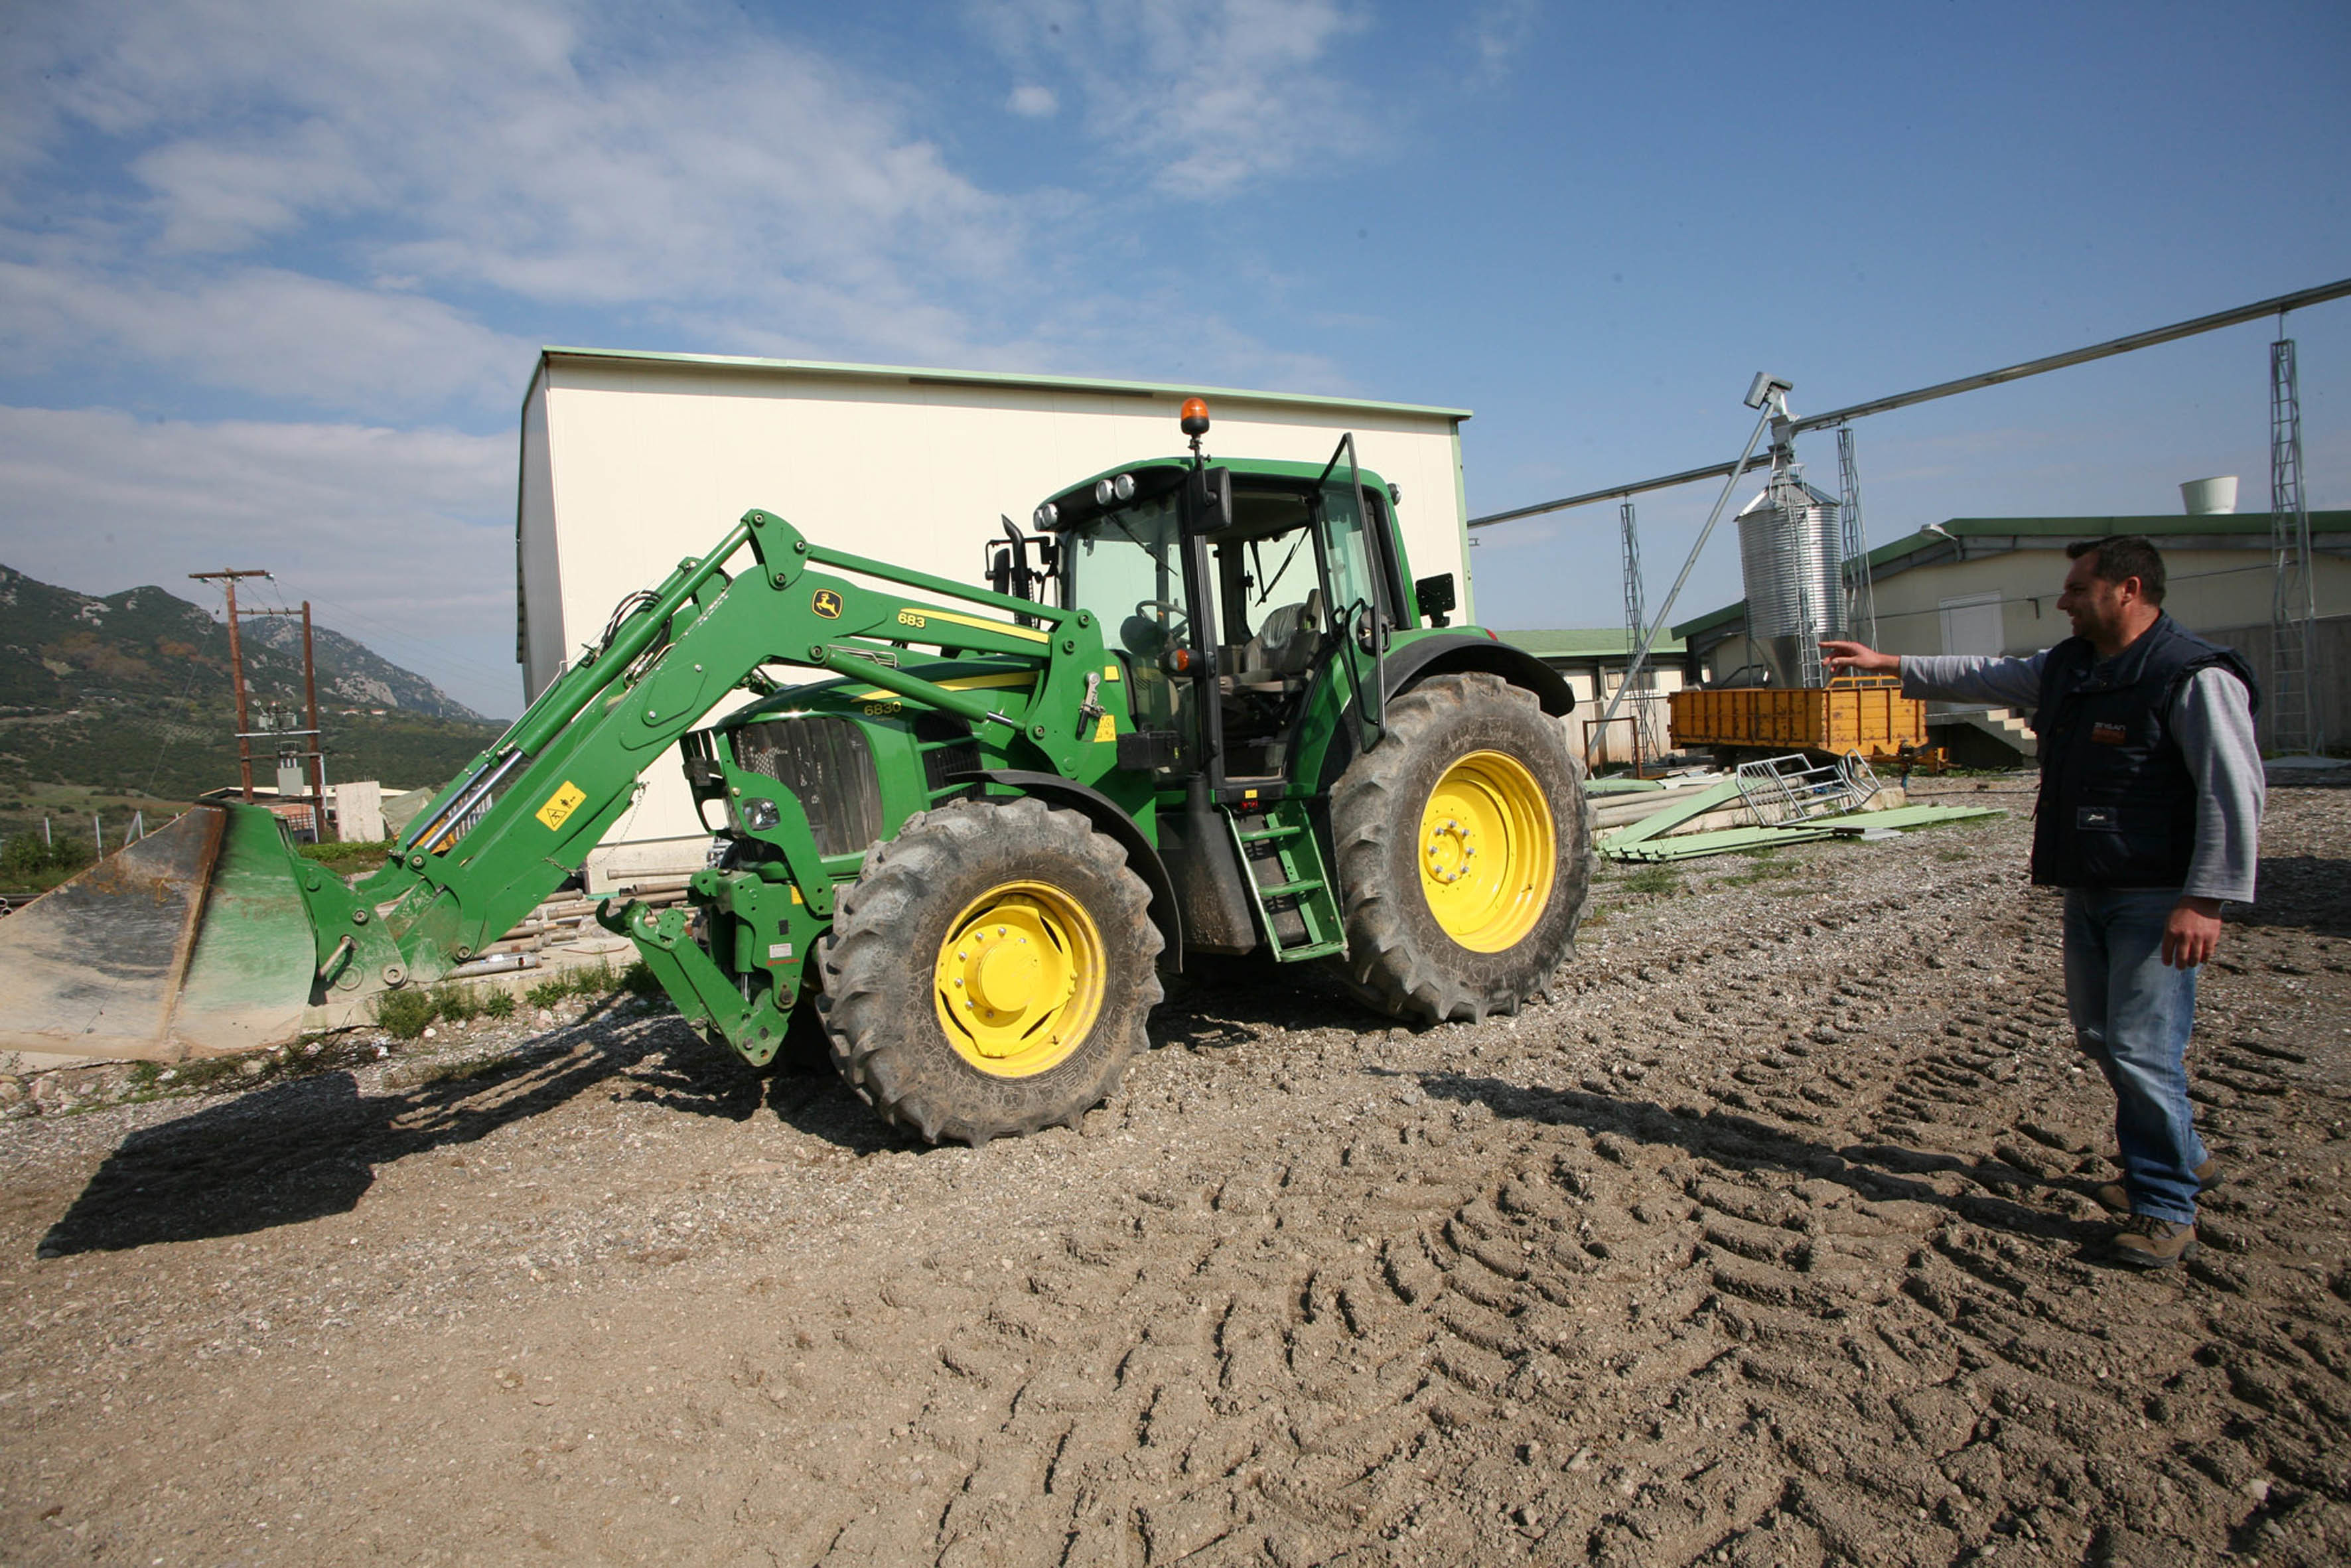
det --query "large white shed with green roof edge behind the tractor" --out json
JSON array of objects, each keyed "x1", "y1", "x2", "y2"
[{"x1": 515, "y1": 348, "x2": 1474, "y2": 891}]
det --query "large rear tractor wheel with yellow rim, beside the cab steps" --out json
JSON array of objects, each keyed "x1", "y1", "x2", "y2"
[{"x1": 1330, "y1": 672, "x2": 1592, "y2": 1023}]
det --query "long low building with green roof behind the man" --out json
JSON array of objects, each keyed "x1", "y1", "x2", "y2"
[{"x1": 1674, "y1": 510, "x2": 2351, "y2": 738}]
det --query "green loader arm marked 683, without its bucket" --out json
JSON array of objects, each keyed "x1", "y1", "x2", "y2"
[{"x1": 303, "y1": 510, "x2": 1103, "y2": 989}]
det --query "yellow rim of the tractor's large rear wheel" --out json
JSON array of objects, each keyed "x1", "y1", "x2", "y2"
[{"x1": 1420, "y1": 752, "x2": 1559, "y2": 952}]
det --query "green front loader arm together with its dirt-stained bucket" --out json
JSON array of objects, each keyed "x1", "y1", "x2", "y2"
[{"x1": 0, "y1": 510, "x2": 1117, "y2": 1060}]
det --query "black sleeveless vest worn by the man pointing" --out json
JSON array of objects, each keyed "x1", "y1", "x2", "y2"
[{"x1": 2034, "y1": 616, "x2": 2261, "y2": 889}]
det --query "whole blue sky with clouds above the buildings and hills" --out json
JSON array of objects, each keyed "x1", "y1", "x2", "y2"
[{"x1": 0, "y1": 0, "x2": 2351, "y2": 715}]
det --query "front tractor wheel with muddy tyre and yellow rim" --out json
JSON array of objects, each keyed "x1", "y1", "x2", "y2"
[{"x1": 818, "y1": 800, "x2": 1164, "y2": 1147}]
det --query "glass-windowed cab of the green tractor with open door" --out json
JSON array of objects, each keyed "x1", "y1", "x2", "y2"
[{"x1": 1036, "y1": 409, "x2": 1403, "y2": 800}]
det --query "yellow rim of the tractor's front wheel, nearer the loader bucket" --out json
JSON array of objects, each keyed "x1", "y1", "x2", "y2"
[{"x1": 931, "y1": 882, "x2": 1105, "y2": 1079}]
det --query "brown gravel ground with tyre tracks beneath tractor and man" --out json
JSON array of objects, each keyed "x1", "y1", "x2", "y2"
[{"x1": 0, "y1": 783, "x2": 2351, "y2": 1565}]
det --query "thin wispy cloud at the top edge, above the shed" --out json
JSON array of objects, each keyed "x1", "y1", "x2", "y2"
[{"x1": 973, "y1": 0, "x2": 1378, "y2": 200}]
